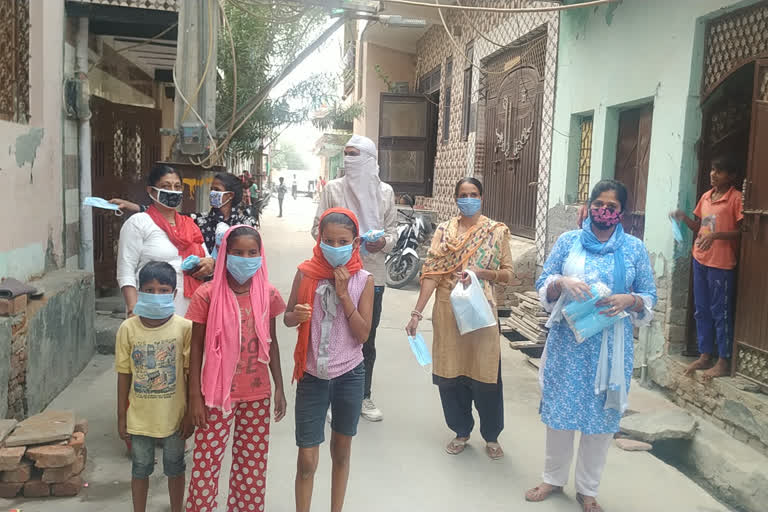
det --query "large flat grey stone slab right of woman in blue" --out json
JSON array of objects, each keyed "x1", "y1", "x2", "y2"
[{"x1": 620, "y1": 409, "x2": 698, "y2": 443}]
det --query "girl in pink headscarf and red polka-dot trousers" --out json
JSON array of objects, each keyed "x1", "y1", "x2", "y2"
[{"x1": 186, "y1": 226, "x2": 286, "y2": 512}]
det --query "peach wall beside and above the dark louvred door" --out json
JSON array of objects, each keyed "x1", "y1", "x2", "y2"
[{"x1": 354, "y1": 42, "x2": 416, "y2": 147}]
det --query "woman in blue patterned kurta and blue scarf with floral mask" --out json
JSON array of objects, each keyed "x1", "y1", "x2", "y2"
[{"x1": 525, "y1": 180, "x2": 656, "y2": 512}]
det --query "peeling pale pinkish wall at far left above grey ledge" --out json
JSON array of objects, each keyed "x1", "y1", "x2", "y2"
[{"x1": 0, "y1": 0, "x2": 64, "y2": 279}]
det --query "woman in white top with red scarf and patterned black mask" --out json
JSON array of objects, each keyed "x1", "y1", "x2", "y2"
[{"x1": 117, "y1": 165, "x2": 213, "y2": 316}]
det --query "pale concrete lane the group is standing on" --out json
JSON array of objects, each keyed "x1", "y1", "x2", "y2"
[{"x1": 0, "y1": 197, "x2": 728, "y2": 512}]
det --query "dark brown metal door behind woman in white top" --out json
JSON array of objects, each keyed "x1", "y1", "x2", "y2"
[{"x1": 91, "y1": 96, "x2": 162, "y2": 289}]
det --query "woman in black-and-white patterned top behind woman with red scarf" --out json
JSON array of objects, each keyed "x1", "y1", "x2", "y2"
[{"x1": 110, "y1": 172, "x2": 259, "y2": 254}]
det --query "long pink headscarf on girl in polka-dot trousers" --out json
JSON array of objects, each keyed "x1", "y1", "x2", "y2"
[{"x1": 201, "y1": 225, "x2": 272, "y2": 414}]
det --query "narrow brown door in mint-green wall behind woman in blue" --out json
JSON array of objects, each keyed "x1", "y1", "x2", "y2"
[{"x1": 614, "y1": 105, "x2": 653, "y2": 240}]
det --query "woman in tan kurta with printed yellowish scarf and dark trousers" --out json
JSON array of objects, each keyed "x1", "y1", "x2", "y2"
[{"x1": 406, "y1": 178, "x2": 512, "y2": 459}]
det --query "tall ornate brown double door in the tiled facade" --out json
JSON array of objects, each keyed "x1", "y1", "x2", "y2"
[{"x1": 483, "y1": 66, "x2": 543, "y2": 238}]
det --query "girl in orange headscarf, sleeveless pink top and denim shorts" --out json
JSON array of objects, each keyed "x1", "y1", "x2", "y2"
[{"x1": 285, "y1": 208, "x2": 373, "y2": 512}]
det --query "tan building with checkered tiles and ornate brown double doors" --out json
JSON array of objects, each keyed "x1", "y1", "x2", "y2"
[{"x1": 355, "y1": 1, "x2": 559, "y2": 303}]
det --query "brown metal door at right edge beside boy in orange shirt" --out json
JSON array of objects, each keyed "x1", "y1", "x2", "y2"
[{"x1": 734, "y1": 59, "x2": 768, "y2": 386}]
